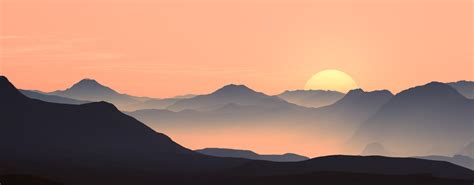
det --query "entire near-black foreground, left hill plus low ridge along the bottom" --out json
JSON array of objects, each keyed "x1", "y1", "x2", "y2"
[{"x1": 0, "y1": 77, "x2": 474, "y2": 185}]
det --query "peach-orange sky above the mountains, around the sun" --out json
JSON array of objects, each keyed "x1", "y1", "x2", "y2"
[{"x1": 0, "y1": 0, "x2": 474, "y2": 97}]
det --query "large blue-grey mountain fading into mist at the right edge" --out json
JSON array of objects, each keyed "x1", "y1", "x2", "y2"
[{"x1": 351, "y1": 82, "x2": 474, "y2": 155}]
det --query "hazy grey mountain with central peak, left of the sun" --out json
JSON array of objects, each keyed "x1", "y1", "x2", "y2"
[{"x1": 167, "y1": 84, "x2": 293, "y2": 111}]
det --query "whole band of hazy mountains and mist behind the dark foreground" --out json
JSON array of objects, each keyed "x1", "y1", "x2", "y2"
[{"x1": 16, "y1": 79, "x2": 473, "y2": 156}]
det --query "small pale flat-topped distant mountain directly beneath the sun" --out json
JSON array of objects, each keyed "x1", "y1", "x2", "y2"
[{"x1": 277, "y1": 90, "x2": 344, "y2": 108}]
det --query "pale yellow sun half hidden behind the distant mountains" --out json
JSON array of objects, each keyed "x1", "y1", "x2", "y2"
[{"x1": 304, "y1": 69, "x2": 358, "y2": 93}]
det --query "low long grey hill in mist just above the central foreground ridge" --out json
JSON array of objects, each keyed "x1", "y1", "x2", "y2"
[{"x1": 195, "y1": 148, "x2": 309, "y2": 162}]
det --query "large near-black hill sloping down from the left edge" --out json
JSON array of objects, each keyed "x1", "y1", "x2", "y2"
[{"x1": 0, "y1": 77, "x2": 246, "y2": 183}]
